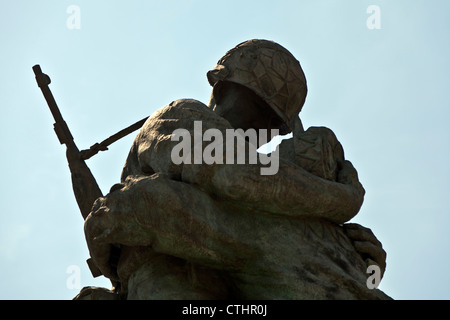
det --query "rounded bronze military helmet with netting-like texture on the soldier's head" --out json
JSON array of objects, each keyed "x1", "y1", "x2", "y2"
[{"x1": 207, "y1": 39, "x2": 307, "y2": 129}]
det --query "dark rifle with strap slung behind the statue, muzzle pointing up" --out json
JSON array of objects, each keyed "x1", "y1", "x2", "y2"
[{"x1": 33, "y1": 65, "x2": 147, "y2": 291}]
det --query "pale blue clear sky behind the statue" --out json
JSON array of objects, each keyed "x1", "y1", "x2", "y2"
[{"x1": 0, "y1": 0, "x2": 450, "y2": 299}]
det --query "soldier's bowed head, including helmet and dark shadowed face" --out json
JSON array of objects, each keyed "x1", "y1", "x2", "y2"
[{"x1": 207, "y1": 40, "x2": 307, "y2": 134}]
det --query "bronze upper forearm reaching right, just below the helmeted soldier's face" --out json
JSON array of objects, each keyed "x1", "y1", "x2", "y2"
[{"x1": 182, "y1": 148, "x2": 364, "y2": 224}]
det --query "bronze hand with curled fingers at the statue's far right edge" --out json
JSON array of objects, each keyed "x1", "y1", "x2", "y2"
[{"x1": 343, "y1": 223, "x2": 386, "y2": 277}]
